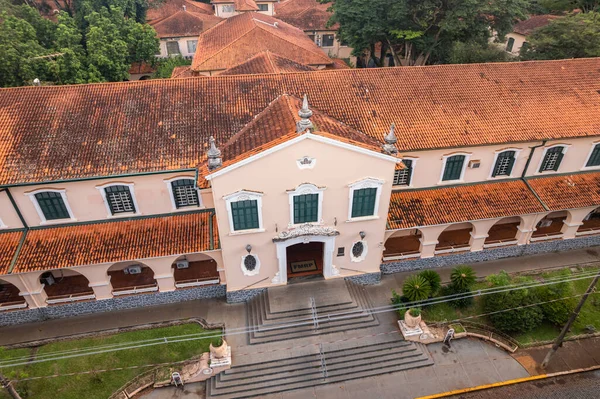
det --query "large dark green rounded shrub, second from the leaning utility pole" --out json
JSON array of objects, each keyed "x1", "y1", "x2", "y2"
[{"x1": 482, "y1": 271, "x2": 544, "y2": 333}]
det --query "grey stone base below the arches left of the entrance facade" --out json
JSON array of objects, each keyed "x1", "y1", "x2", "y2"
[{"x1": 0, "y1": 285, "x2": 226, "y2": 326}]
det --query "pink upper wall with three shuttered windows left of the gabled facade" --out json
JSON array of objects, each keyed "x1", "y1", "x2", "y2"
[{"x1": 0, "y1": 172, "x2": 213, "y2": 226}]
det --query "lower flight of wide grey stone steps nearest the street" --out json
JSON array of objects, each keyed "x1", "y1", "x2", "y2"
[{"x1": 206, "y1": 334, "x2": 433, "y2": 399}]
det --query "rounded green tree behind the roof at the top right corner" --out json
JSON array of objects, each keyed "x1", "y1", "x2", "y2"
[{"x1": 521, "y1": 12, "x2": 600, "y2": 60}]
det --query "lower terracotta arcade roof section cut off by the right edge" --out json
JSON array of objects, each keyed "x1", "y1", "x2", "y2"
[{"x1": 527, "y1": 172, "x2": 600, "y2": 211}]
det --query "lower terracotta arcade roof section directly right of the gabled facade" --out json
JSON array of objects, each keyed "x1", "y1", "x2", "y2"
[{"x1": 387, "y1": 180, "x2": 545, "y2": 230}]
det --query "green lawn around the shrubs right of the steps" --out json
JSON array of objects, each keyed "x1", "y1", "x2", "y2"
[{"x1": 422, "y1": 268, "x2": 600, "y2": 344}]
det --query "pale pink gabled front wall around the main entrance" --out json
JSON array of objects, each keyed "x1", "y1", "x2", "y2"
[{"x1": 211, "y1": 140, "x2": 395, "y2": 291}]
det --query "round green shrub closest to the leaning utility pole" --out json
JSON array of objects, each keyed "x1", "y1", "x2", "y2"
[{"x1": 536, "y1": 271, "x2": 577, "y2": 326}]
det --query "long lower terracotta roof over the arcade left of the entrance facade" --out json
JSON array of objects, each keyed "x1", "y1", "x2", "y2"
[{"x1": 12, "y1": 212, "x2": 219, "y2": 273}]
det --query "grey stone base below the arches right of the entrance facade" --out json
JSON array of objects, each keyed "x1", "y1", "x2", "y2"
[{"x1": 381, "y1": 236, "x2": 600, "y2": 274}]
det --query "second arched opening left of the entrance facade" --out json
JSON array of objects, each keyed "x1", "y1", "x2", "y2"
[{"x1": 107, "y1": 261, "x2": 158, "y2": 296}]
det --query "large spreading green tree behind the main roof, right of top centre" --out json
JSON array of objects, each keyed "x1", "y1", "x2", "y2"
[{"x1": 330, "y1": 0, "x2": 528, "y2": 65}]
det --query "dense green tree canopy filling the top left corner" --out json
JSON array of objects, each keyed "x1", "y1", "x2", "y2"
[{"x1": 0, "y1": 0, "x2": 159, "y2": 87}]
